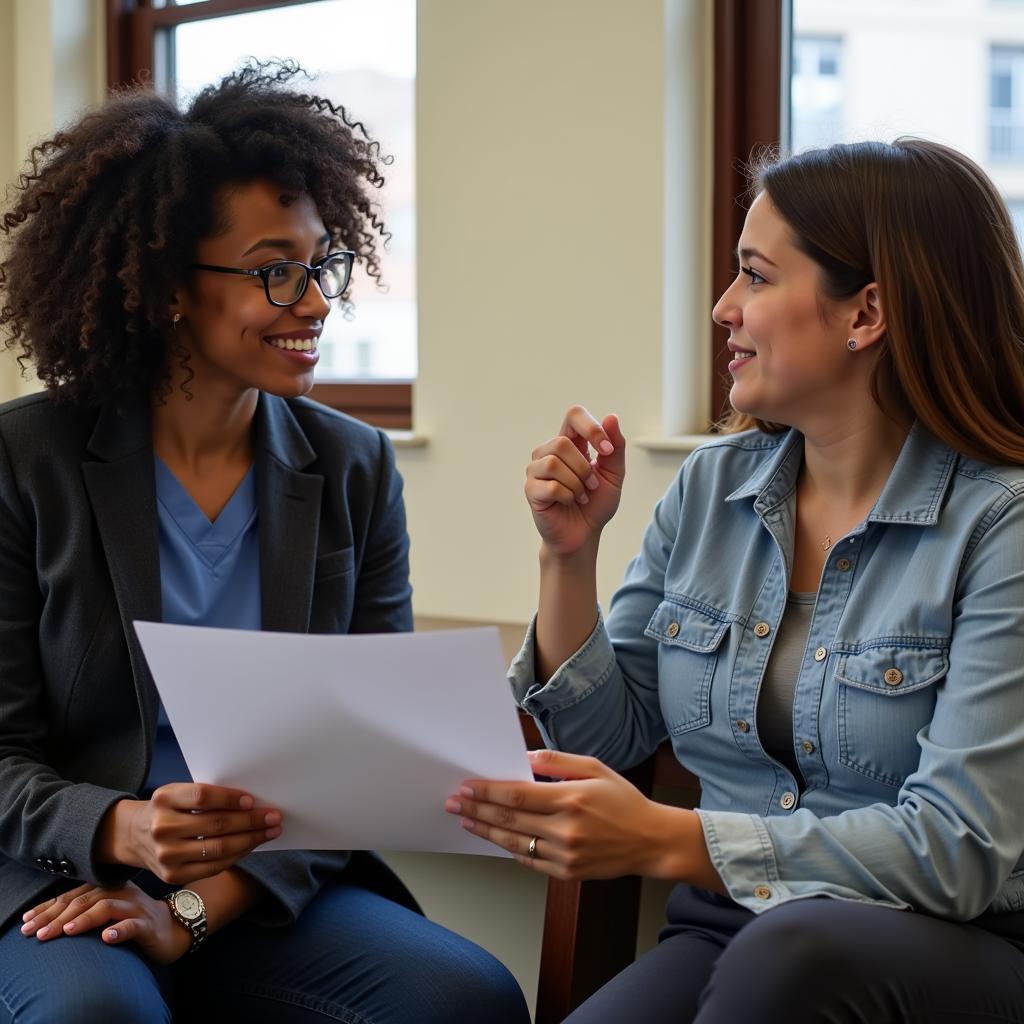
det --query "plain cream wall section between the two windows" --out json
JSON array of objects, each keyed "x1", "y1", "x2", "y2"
[{"x1": 399, "y1": 0, "x2": 711, "y2": 622}]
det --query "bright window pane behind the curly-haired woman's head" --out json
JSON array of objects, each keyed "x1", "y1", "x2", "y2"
[{"x1": 167, "y1": 0, "x2": 417, "y2": 382}]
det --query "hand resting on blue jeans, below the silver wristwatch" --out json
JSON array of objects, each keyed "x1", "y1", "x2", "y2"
[{"x1": 22, "y1": 882, "x2": 191, "y2": 964}]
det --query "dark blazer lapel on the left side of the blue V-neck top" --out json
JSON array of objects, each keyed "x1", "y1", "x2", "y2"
[{"x1": 82, "y1": 402, "x2": 162, "y2": 764}]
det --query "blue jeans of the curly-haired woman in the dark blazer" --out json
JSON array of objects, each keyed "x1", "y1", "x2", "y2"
[{"x1": 0, "y1": 884, "x2": 529, "y2": 1024}]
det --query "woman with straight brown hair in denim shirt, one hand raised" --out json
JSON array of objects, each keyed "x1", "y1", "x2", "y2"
[{"x1": 447, "y1": 138, "x2": 1024, "y2": 1024}]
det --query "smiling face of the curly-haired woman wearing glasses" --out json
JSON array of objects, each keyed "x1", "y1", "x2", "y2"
[{"x1": 172, "y1": 180, "x2": 331, "y2": 397}]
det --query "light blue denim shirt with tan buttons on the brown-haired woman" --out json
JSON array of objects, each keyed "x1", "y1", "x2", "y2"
[{"x1": 510, "y1": 425, "x2": 1024, "y2": 920}]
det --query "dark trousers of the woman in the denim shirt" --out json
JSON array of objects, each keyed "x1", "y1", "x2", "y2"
[{"x1": 566, "y1": 886, "x2": 1024, "y2": 1024}]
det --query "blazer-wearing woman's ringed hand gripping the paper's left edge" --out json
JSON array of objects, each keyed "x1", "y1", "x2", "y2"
[{"x1": 96, "y1": 782, "x2": 282, "y2": 886}]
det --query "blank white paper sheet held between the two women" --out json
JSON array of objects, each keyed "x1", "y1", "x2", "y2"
[{"x1": 135, "y1": 622, "x2": 532, "y2": 856}]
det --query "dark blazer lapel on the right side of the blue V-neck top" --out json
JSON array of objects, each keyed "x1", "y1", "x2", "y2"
[{"x1": 256, "y1": 393, "x2": 324, "y2": 633}]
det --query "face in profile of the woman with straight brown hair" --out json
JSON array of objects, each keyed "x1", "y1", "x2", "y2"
[{"x1": 712, "y1": 193, "x2": 879, "y2": 433}]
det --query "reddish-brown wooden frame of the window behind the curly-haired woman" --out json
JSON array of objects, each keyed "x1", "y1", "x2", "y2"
[{"x1": 106, "y1": 0, "x2": 413, "y2": 430}]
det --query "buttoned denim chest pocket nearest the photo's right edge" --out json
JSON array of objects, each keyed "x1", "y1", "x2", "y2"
[{"x1": 836, "y1": 644, "x2": 949, "y2": 786}]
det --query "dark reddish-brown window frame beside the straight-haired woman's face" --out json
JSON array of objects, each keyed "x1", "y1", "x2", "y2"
[{"x1": 709, "y1": 0, "x2": 790, "y2": 419}]
